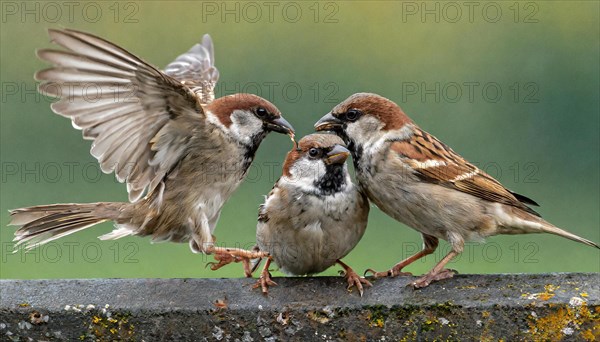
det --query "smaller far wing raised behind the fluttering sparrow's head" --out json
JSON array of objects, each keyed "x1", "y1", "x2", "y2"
[{"x1": 165, "y1": 34, "x2": 219, "y2": 104}]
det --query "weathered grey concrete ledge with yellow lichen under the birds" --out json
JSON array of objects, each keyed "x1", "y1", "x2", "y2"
[{"x1": 0, "y1": 274, "x2": 600, "y2": 341}]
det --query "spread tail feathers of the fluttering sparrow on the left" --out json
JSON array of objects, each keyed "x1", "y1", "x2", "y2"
[{"x1": 9, "y1": 202, "x2": 122, "y2": 250}]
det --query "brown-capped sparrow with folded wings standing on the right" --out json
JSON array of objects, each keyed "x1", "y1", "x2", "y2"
[{"x1": 315, "y1": 93, "x2": 600, "y2": 288}]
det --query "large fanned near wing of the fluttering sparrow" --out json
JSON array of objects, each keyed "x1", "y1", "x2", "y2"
[{"x1": 35, "y1": 29, "x2": 204, "y2": 202}]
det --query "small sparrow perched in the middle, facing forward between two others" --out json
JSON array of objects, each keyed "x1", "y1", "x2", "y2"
[{"x1": 255, "y1": 134, "x2": 371, "y2": 296}]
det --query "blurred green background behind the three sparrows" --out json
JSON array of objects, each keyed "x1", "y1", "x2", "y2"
[{"x1": 0, "y1": 1, "x2": 600, "y2": 278}]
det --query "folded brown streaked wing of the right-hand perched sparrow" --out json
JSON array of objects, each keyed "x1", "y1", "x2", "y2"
[{"x1": 392, "y1": 128, "x2": 539, "y2": 216}]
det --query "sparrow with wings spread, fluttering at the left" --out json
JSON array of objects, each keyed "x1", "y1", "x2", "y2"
[{"x1": 10, "y1": 29, "x2": 294, "y2": 274}]
